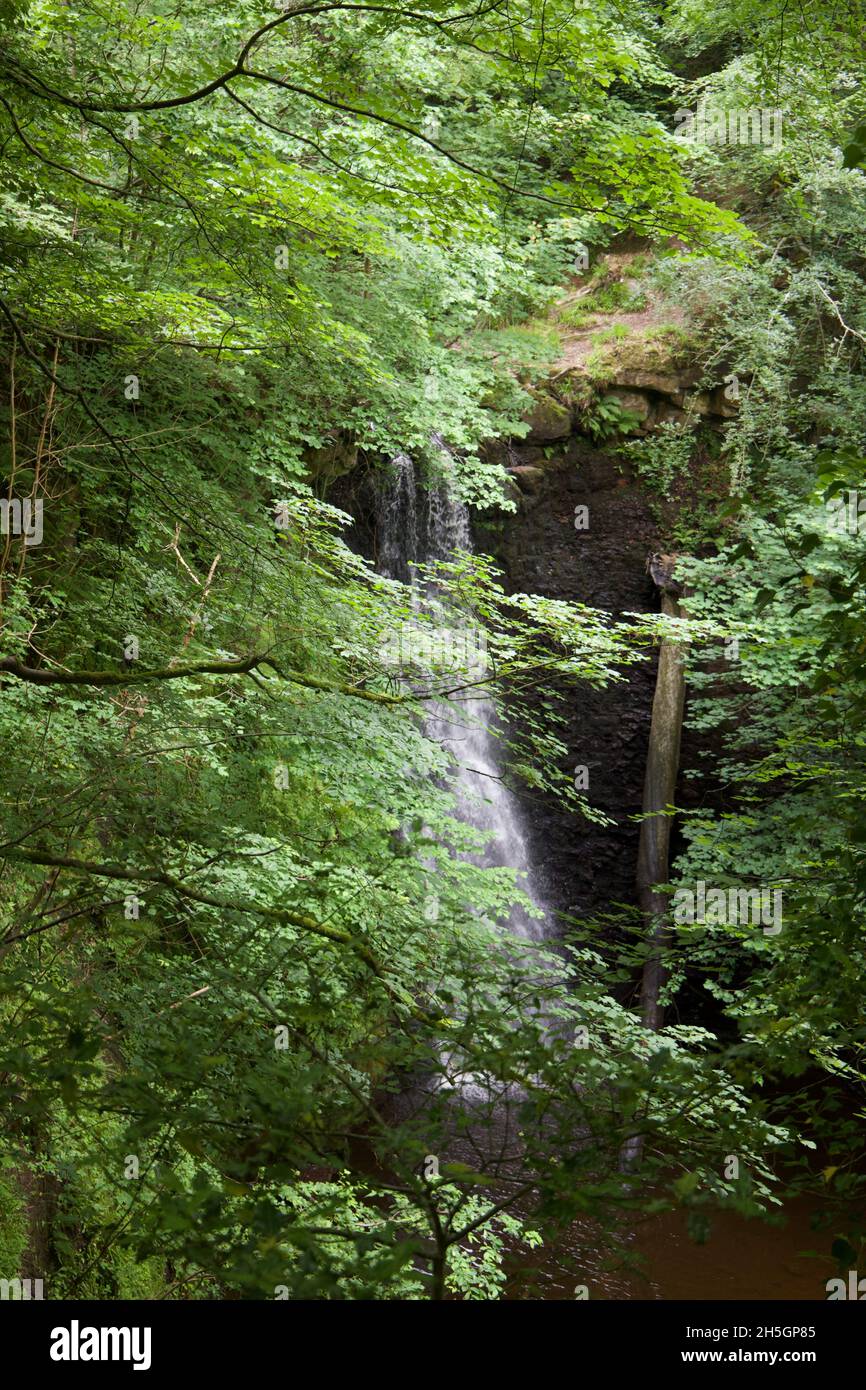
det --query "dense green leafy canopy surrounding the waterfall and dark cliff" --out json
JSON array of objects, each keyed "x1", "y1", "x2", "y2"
[{"x1": 0, "y1": 0, "x2": 866, "y2": 1298}]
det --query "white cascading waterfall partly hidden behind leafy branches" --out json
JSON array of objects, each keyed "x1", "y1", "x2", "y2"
[{"x1": 377, "y1": 455, "x2": 545, "y2": 941}]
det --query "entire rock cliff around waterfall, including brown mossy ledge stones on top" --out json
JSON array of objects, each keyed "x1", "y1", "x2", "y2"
[{"x1": 332, "y1": 319, "x2": 737, "y2": 939}]
